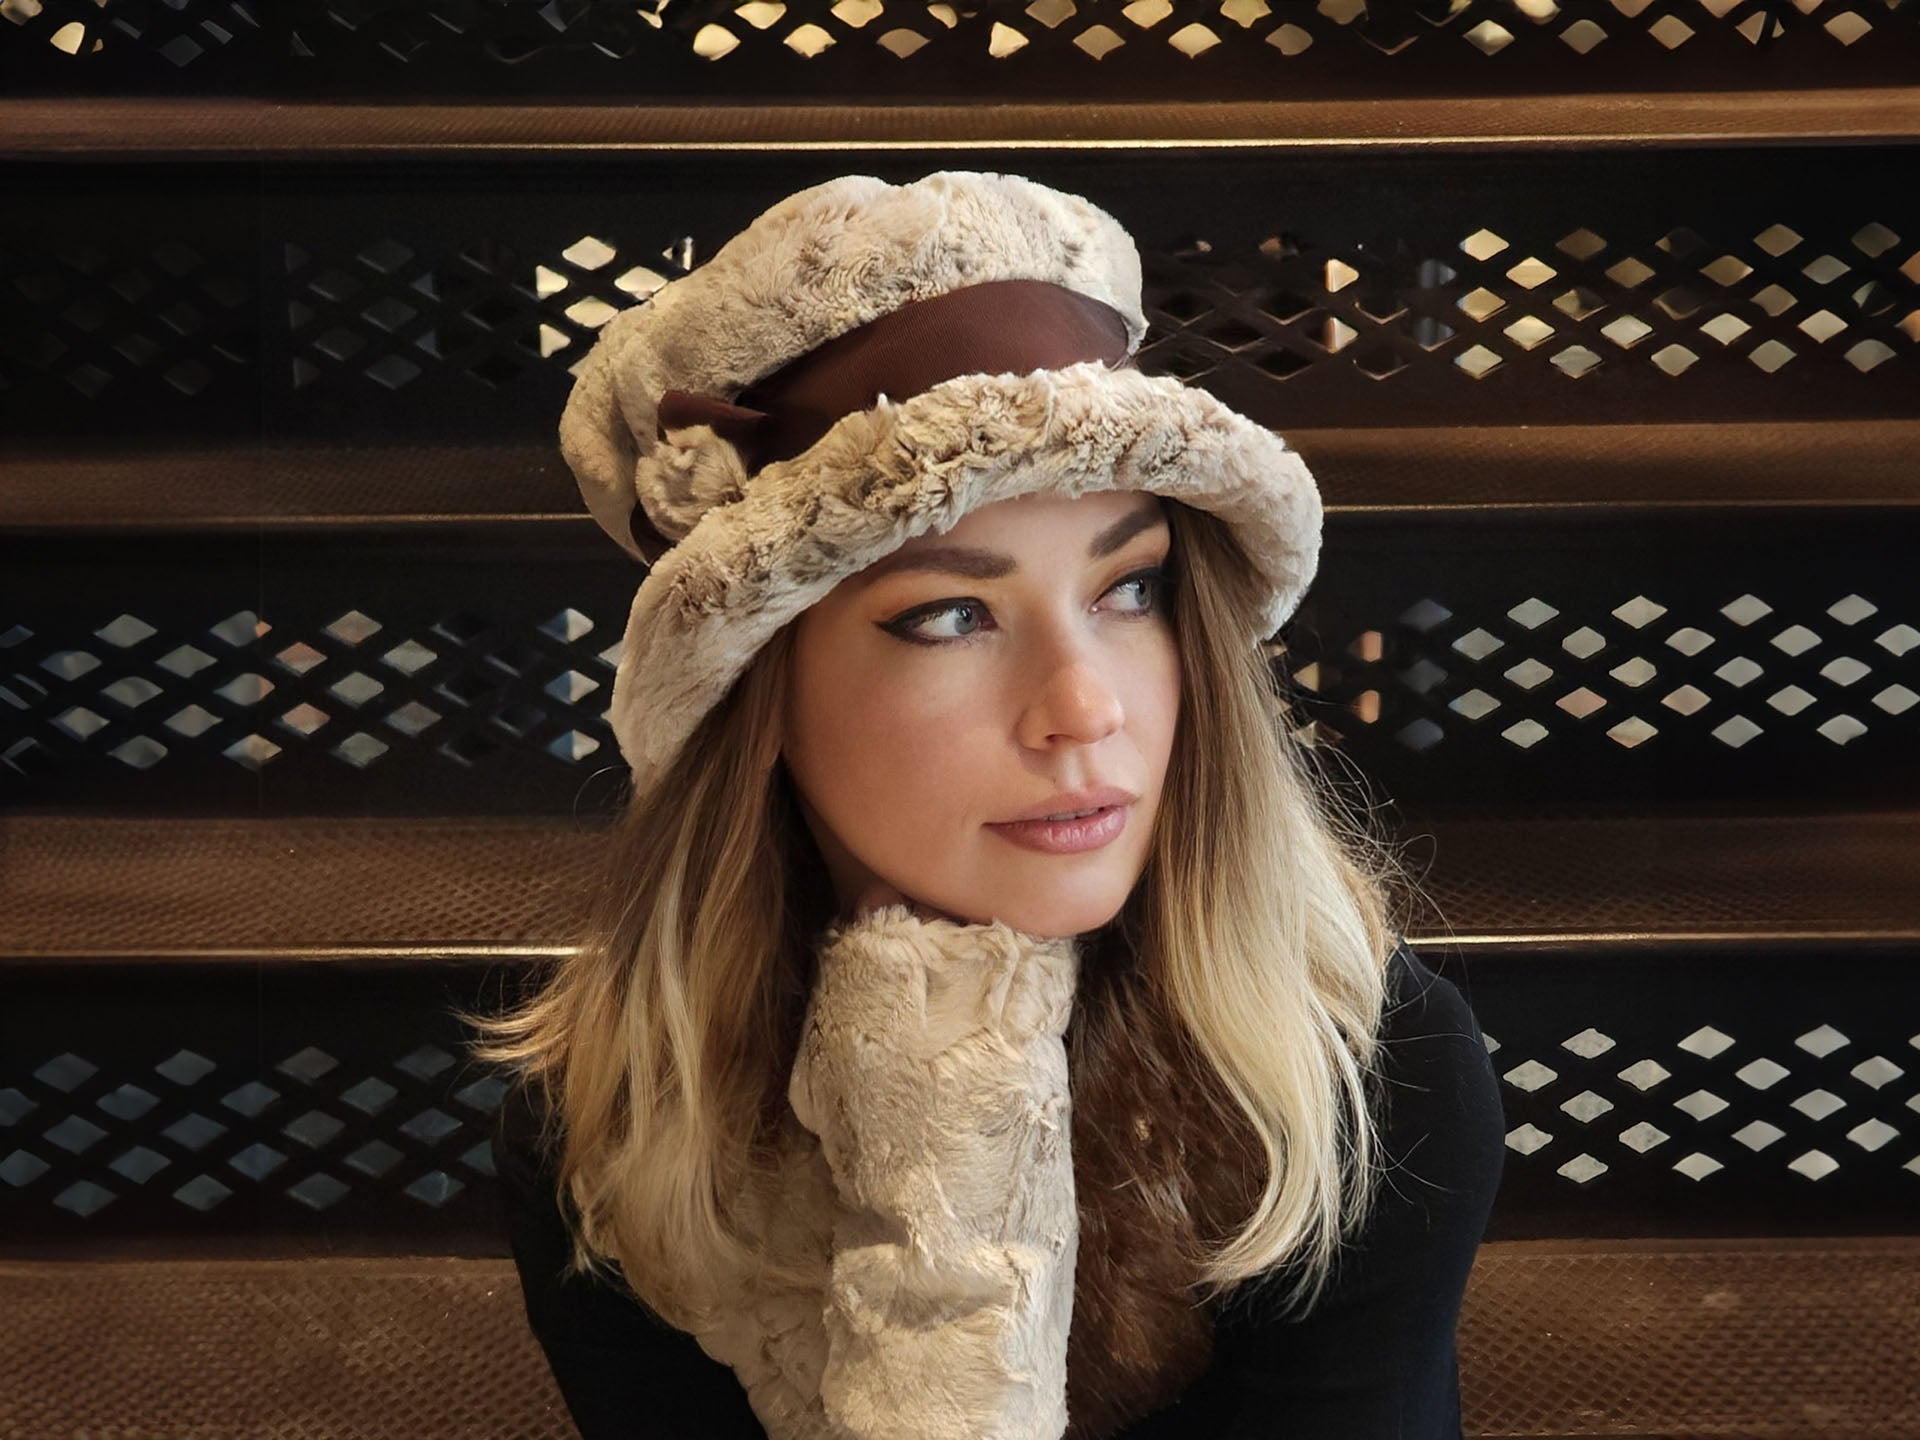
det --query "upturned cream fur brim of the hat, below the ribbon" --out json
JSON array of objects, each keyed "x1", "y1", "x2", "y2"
[{"x1": 609, "y1": 361, "x2": 1321, "y2": 791}]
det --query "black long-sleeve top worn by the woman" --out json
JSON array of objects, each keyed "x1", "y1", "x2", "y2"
[{"x1": 493, "y1": 941, "x2": 1505, "y2": 1440}]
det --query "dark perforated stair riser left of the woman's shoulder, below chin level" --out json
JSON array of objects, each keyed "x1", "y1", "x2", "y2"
[{"x1": 0, "y1": 960, "x2": 541, "y2": 1254}]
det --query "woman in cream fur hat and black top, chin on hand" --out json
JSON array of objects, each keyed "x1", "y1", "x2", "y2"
[{"x1": 474, "y1": 171, "x2": 1503, "y2": 1440}]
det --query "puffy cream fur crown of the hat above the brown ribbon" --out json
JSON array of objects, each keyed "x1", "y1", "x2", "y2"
[{"x1": 561, "y1": 171, "x2": 1146, "y2": 557}]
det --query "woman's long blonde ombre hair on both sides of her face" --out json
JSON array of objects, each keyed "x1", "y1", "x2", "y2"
[{"x1": 465, "y1": 499, "x2": 1428, "y2": 1331}]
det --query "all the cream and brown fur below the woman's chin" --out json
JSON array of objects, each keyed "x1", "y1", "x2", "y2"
[{"x1": 683, "y1": 906, "x2": 1258, "y2": 1440}]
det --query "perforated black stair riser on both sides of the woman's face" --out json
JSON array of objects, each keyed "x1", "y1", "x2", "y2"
[{"x1": 0, "y1": 514, "x2": 1920, "y2": 816}]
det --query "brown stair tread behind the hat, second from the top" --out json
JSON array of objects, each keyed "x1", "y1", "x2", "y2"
[{"x1": 0, "y1": 419, "x2": 1920, "y2": 532}]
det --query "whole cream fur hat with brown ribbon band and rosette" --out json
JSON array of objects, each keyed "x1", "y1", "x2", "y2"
[{"x1": 561, "y1": 171, "x2": 1321, "y2": 793}]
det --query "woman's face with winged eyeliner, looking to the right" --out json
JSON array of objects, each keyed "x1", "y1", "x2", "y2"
[{"x1": 783, "y1": 492, "x2": 1181, "y2": 935}]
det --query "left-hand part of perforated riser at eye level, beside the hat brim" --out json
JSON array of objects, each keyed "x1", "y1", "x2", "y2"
[{"x1": 0, "y1": 516, "x2": 641, "y2": 814}]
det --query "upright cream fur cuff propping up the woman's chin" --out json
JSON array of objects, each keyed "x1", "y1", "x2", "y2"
[{"x1": 787, "y1": 904, "x2": 1079, "y2": 1440}]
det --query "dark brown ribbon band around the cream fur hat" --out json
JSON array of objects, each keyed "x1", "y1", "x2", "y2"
[{"x1": 630, "y1": 280, "x2": 1133, "y2": 564}]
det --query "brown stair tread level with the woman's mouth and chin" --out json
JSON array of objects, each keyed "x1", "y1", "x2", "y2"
[{"x1": 0, "y1": 812, "x2": 1920, "y2": 962}]
